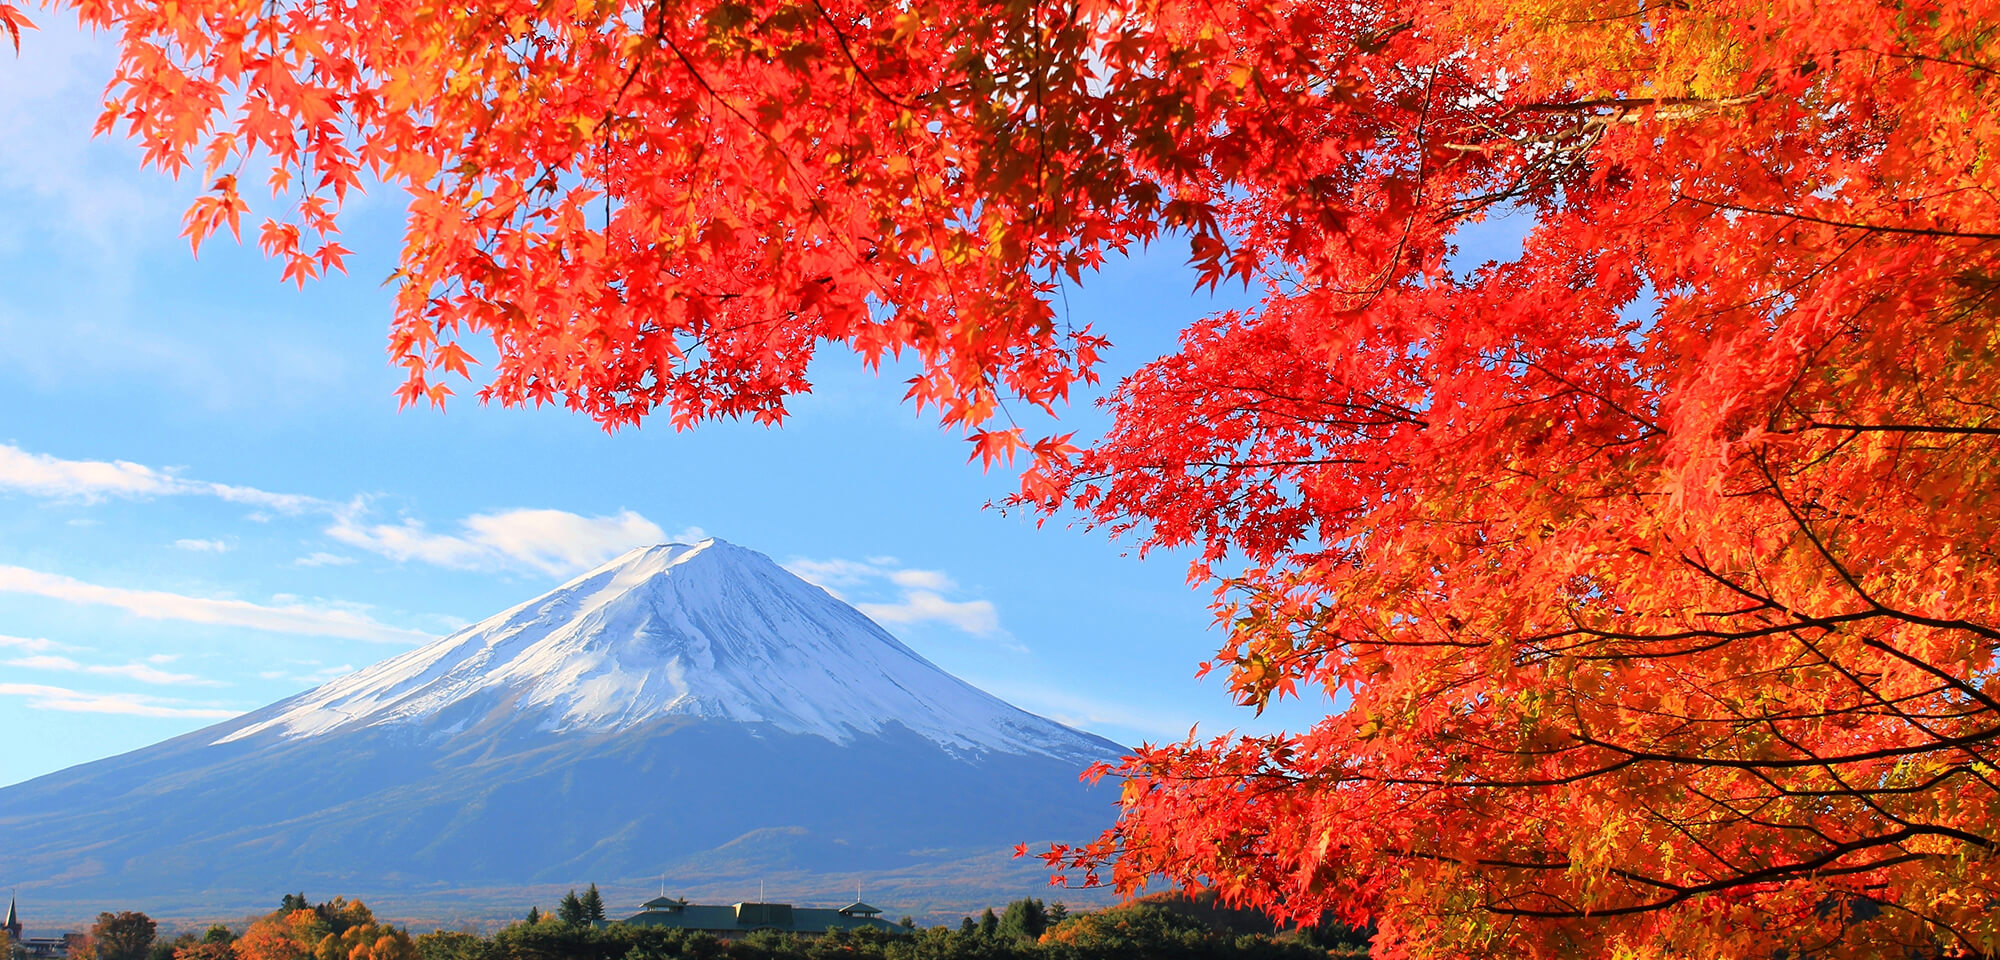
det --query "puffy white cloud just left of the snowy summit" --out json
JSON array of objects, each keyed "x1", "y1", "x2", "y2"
[{"x1": 326, "y1": 510, "x2": 666, "y2": 576}]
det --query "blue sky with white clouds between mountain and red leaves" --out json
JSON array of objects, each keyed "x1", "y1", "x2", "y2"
[{"x1": 0, "y1": 12, "x2": 1360, "y2": 784}]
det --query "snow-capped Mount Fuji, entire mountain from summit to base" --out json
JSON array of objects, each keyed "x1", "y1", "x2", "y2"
[{"x1": 0, "y1": 540, "x2": 1124, "y2": 916}]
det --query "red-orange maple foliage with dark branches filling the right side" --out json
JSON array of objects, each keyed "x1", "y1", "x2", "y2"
[{"x1": 1016, "y1": 2, "x2": 2000, "y2": 956}]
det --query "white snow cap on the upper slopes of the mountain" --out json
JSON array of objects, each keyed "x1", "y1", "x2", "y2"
[{"x1": 227, "y1": 540, "x2": 1116, "y2": 764}]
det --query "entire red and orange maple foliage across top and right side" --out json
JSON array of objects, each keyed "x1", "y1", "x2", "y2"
[{"x1": 27, "y1": 0, "x2": 2000, "y2": 960}]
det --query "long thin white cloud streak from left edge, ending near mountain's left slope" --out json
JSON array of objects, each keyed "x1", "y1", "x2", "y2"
[{"x1": 0, "y1": 566, "x2": 430, "y2": 644}]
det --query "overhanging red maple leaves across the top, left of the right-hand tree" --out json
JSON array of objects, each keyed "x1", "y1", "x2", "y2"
[{"x1": 76, "y1": 0, "x2": 1160, "y2": 442}]
